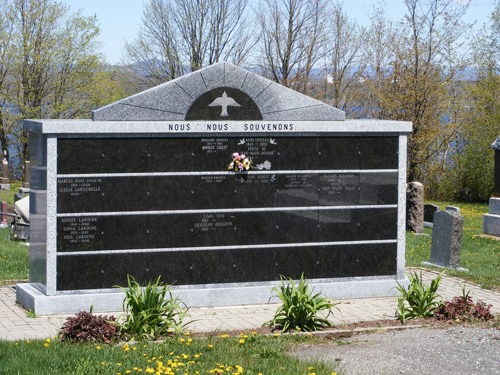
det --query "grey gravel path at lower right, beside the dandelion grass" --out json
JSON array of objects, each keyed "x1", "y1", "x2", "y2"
[{"x1": 295, "y1": 327, "x2": 500, "y2": 375}]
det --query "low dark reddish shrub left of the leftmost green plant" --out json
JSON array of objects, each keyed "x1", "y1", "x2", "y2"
[{"x1": 59, "y1": 311, "x2": 120, "y2": 344}]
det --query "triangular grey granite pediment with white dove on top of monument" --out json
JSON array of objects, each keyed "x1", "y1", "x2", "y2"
[{"x1": 92, "y1": 62, "x2": 345, "y2": 121}]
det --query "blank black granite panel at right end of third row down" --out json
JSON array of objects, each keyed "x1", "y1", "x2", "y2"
[{"x1": 358, "y1": 208, "x2": 398, "y2": 240}]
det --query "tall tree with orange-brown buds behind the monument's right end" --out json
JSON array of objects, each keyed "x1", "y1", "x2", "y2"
[{"x1": 365, "y1": 0, "x2": 469, "y2": 184}]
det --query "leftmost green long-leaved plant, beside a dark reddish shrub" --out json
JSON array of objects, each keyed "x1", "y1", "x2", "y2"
[{"x1": 116, "y1": 275, "x2": 189, "y2": 339}]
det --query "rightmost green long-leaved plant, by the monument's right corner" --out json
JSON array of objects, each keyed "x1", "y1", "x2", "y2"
[{"x1": 396, "y1": 269, "x2": 444, "y2": 323}]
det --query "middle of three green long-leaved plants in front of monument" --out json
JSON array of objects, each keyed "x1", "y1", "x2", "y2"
[{"x1": 263, "y1": 274, "x2": 338, "y2": 332}]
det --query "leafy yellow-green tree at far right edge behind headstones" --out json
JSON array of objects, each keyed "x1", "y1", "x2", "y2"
[{"x1": 441, "y1": 1, "x2": 500, "y2": 202}]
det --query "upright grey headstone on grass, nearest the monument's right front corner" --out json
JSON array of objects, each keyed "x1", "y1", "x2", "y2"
[{"x1": 430, "y1": 210, "x2": 464, "y2": 268}]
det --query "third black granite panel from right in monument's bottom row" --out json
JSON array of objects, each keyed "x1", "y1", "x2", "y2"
[{"x1": 276, "y1": 247, "x2": 320, "y2": 279}]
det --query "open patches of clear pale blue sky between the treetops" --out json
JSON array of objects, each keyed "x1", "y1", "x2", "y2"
[{"x1": 65, "y1": 0, "x2": 494, "y2": 64}]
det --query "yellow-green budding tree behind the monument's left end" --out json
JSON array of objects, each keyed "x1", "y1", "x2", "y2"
[{"x1": 0, "y1": 0, "x2": 121, "y2": 176}]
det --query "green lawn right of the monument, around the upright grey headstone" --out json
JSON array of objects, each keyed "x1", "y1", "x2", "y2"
[{"x1": 406, "y1": 202, "x2": 500, "y2": 289}]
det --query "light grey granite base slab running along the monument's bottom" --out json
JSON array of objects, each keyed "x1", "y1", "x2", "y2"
[{"x1": 16, "y1": 276, "x2": 409, "y2": 315}]
